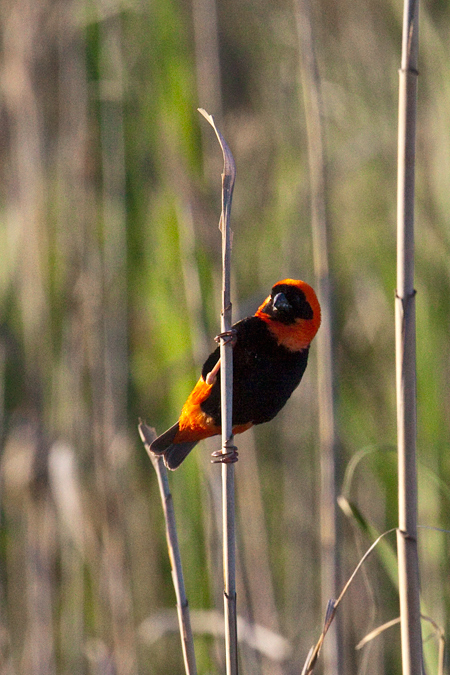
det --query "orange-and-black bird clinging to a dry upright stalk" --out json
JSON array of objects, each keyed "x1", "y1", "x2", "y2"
[{"x1": 149, "y1": 279, "x2": 321, "y2": 470}]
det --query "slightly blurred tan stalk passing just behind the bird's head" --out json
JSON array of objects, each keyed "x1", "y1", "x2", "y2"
[{"x1": 296, "y1": 0, "x2": 341, "y2": 675}]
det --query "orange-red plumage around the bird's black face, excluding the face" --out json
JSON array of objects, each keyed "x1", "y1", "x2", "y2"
[{"x1": 255, "y1": 279, "x2": 321, "y2": 352}]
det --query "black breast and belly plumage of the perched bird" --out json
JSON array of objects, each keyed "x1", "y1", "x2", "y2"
[{"x1": 201, "y1": 316, "x2": 309, "y2": 425}]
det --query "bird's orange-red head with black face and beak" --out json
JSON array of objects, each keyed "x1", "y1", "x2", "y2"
[{"x1": 255, "y1": 279, "x2": 321, "y2": 351}]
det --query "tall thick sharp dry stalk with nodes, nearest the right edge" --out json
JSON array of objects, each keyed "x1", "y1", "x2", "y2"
[{"x1": 395, "y1": 0, "x2": 424, "y2": 675}]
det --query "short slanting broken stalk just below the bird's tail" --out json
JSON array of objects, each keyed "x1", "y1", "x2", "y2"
[{"x1": 138, "y1": 422, "x2": 197, "y2": 675}]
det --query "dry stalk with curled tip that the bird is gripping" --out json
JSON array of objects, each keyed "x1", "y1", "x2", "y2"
[{"x1": 199, "y1": 109, "x2": 238, "y2": 675}]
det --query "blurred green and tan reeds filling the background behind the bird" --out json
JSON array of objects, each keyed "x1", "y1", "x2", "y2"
[{"x1": 0, "y1": 0, "x2": 450, "y2": 675}]
